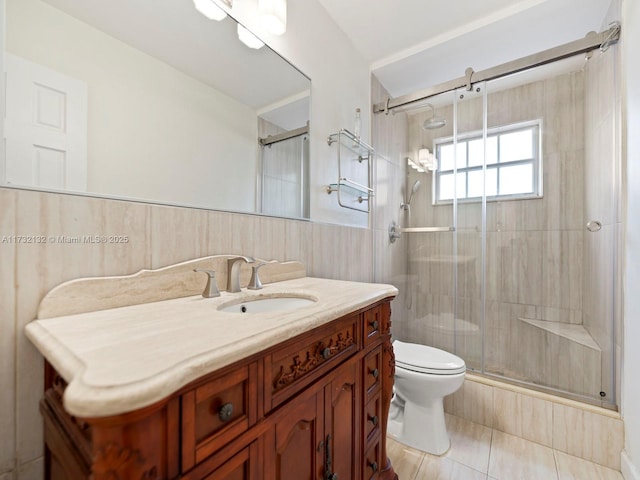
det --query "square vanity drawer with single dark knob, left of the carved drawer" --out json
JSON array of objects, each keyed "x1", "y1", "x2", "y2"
[{"x1": 182, "y1": 363, "x2": 257, "y2": 470}]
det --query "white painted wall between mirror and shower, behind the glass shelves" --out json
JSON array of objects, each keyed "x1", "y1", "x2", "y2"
[{"x1": 233, "y1": 0, "x2": 371, "y2": 226}]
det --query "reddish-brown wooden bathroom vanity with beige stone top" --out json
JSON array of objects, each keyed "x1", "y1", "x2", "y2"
[{"x1": 26, "y1": 257, "x2": 397, "y2": 480}]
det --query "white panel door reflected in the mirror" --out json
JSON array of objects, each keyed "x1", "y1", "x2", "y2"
[{"x1": 4, "y1": 54, "x2": 87, "y2": 192}]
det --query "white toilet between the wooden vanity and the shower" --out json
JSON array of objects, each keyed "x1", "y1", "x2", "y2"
[{"x1": 387, "y1": 340, "x2": 466, "y2": 455}]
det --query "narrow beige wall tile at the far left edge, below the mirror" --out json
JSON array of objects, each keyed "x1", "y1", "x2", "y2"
[{"x1": 0, "y1": 188, "x2": 16, "y2": 472}]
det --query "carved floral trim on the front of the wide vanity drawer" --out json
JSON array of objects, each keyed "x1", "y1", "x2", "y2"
[{"x1": 273, "y1": 331, "x2": 355, "y2": 391}]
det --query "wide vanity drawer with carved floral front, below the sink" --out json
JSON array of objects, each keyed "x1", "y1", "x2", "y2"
[{"x1": 264, "y1": 315, "x2": 361, "y2": 412}]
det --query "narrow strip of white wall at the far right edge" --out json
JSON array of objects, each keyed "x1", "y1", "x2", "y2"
[{"x1": 621, "y1": 0, "x2": 640, "y2": 480}]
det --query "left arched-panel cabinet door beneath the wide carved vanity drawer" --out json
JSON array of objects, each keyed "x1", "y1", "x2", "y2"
[{"x1": 265, "y1": 390, "x2": 325, "y2": 480}]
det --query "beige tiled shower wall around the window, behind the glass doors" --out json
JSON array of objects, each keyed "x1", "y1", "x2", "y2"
[{"x1": 396, "y1": 63, "x2": 613, "y2": 398}]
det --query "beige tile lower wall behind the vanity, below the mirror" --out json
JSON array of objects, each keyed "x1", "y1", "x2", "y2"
[{"x1": 0, "y1": 188, "x2": 373, "y2": 480}]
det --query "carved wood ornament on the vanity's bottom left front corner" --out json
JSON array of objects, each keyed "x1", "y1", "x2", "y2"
[{"x1": 90, "y1": 443, "x2": 158, "y2": 480}]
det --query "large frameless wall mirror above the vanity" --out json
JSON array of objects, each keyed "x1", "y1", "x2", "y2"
[{"x1": 0, "y1": 0, "x2": 310, "y2": 217}]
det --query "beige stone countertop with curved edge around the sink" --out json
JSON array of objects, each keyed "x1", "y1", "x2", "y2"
[{"x1": 25, "y1": 277, "x2": 398, "y2": 417}]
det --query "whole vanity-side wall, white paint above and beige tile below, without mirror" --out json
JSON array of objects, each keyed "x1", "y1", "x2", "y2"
[{"x1": 0, "y1": 0, "x2": 376, "y2": 480}]
